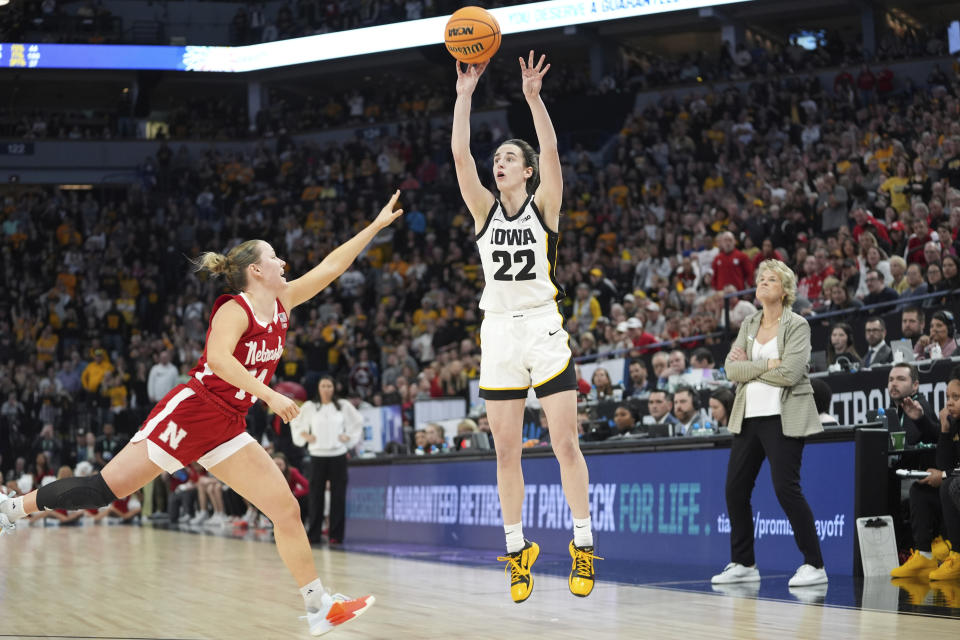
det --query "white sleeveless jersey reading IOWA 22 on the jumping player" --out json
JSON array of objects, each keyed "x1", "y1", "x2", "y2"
[{"x1": 477, "y1": 196, "x2": 564, "y2": 312}]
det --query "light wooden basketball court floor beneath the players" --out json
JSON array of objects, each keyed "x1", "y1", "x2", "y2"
[{"x1": 0, "y1": 526, "x2": 960, "y2": 640}]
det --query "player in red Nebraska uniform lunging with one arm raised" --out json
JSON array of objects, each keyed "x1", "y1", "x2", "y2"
[{"x1": 0, "y1": 191, "x2": 403, "y2": 635}]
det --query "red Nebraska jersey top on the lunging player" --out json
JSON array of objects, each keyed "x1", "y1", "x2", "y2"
[{"x1": 190, "y1": 293, "x2": 287, "y2": 414}]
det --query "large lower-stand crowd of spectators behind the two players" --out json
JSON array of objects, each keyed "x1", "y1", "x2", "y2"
[{"x1": 0, "y1": 33, "x2": 960, "y2": 490}]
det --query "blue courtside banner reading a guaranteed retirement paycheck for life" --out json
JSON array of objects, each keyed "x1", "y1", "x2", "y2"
[{"x1": 347, "y1": 442, "x2": 856, "y2": 575}]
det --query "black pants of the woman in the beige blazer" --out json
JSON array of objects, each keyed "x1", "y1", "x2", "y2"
[{"x1": 726, "y1": 416, "x2": 823, "y2": 568}]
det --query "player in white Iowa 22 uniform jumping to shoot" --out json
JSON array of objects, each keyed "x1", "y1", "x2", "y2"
[{"x1": 451, "y1": 51, "x2": 596, "y2": 602}]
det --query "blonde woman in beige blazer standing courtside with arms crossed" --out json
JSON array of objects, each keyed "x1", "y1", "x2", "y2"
[{"x1": 711, "y1": 260, "x2": 827, "y2": 587}]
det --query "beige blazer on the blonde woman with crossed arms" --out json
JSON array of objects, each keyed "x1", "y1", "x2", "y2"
[{"x1": 724, "y1": 309, "x2": 823, "y2": 438}]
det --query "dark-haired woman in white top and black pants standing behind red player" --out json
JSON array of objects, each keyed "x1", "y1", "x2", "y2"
[{"x1": 290, "y1": 375, "x2": 364, "y2": 544}]
